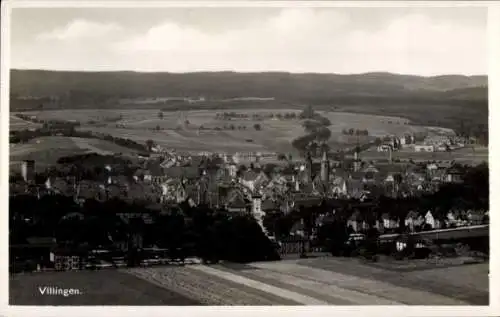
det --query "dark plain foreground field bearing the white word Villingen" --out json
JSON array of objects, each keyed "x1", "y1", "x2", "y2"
[{"x1": 9, "y1": 270, "x2": 200, "y2": 306}]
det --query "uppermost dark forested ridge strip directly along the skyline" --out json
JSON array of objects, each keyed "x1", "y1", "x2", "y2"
[{"x1": 11, "y1": 70, "x2": 487, "y2": 101}]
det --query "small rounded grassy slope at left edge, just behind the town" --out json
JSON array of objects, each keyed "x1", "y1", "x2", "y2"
[{"x1": 9, "y1": 136, "x2": 139, "y2": 168}]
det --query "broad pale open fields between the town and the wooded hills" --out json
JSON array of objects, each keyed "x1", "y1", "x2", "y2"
[{"x1": 15, "y1": 108, "x2": 456, "y2": 152}]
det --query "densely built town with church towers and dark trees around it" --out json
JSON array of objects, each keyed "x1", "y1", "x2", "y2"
[{"x1": 10, "y1": 106, "x2": 489, "y2": 271}]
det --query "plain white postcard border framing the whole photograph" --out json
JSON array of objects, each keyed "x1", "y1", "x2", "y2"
[{"x1": 0, "y1": 0, "x2": 500, "y2": 317}]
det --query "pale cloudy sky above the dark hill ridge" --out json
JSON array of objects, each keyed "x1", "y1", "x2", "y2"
[{"x1": 10, "y1": 7, "x2": 488, "y2": 76}]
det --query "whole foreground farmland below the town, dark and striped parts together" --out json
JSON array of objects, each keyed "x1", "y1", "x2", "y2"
[{"x1": 10, "y1": 257, "x2": 489, "y2": 305}]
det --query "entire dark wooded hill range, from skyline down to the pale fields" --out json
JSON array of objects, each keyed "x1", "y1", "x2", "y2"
[{"x1": 10, "y1": 70, "x2": 488, "y2": 133}]
